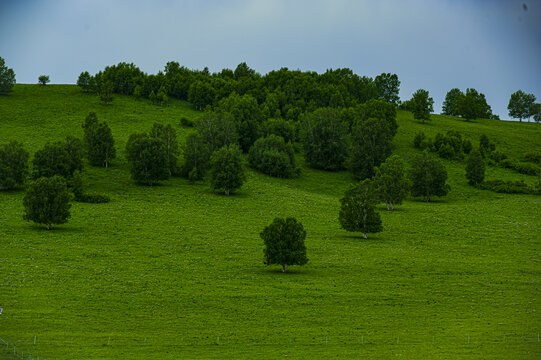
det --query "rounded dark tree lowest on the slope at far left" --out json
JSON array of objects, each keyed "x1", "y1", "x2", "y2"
[{"x1": 23, "y1": 176, "x2": 71, "y2": 230}]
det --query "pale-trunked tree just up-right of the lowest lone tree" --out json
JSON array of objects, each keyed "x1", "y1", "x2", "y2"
[{"x1": 338, "y1": 179, "x2": 383, "y2": 239}]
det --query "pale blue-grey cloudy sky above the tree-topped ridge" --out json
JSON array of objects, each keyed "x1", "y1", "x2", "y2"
[{"x1": 0, "y1": 0, "x2": 541, "y2": 119}]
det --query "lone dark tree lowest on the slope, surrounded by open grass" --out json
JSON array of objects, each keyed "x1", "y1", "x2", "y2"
[{"x1": 260, "y1": 217, "x2": 308, "y2": 273}]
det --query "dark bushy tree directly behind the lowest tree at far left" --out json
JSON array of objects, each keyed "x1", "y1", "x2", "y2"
[{"x1": 32, "y1": 141, "x2": 73, "y2": 179}]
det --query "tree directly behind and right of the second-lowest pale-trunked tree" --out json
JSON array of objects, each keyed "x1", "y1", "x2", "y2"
[{"x1": 374, "y1": 155, "x2": 410, "y2": 210}]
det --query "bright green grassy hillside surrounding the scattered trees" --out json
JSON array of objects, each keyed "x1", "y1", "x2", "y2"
[{"x1": 0, "y1": 85, "x2": 541, "y2": 359}]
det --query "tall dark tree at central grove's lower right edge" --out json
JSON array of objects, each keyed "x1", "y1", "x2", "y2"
[{"x1": 348, "y1": 118, "x2": 393, "y2": 179}]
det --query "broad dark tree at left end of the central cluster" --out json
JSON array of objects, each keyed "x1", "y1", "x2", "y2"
[{"x1": 126, "y1": 133, "x2": 170, "y2": 186}]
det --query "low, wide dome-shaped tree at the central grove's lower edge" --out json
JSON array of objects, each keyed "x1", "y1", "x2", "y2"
[{"x1": 248, "y1": 134, "x2": 297, "y2": 178}]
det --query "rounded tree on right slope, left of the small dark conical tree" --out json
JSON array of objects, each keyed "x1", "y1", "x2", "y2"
[{"x1": 410, "y1": 152, "x2": 451, "y2": 202}]
